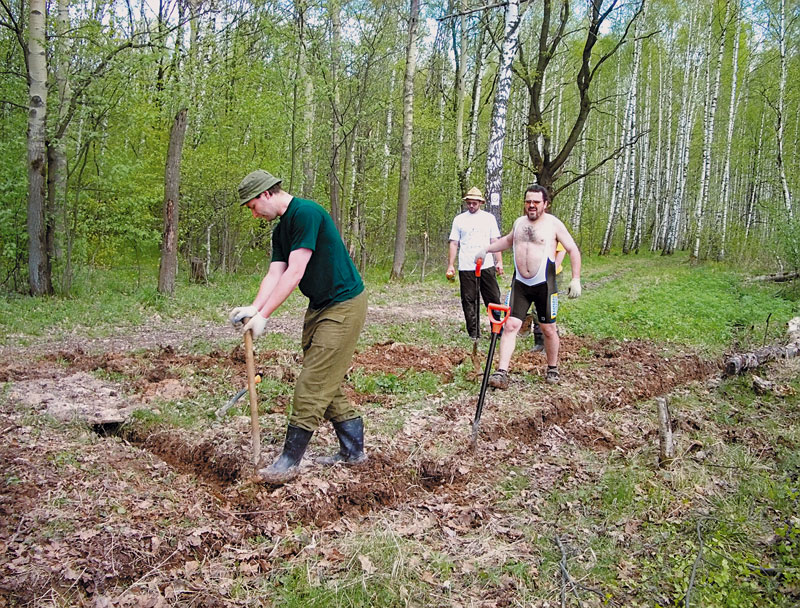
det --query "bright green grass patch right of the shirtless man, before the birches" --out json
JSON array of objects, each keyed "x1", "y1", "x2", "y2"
[{"x1": 559, "y1": 254, "x2": 800, "y2": 353}]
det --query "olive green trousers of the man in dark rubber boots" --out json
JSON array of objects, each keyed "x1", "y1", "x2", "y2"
[{"x1": 289, "y1": 291, "x2": 367, "y2": 432}]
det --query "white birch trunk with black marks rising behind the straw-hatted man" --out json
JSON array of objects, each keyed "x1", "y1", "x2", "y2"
[{"x1": 486, "y1": 0, "x2": 520, "y2": 226}]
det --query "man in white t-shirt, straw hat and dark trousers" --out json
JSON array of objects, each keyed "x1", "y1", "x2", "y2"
[{"x1": 446, "y1": 187, "x2": 503, "y2": 339}]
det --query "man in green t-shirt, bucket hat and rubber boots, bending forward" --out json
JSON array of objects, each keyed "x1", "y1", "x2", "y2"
[{"x1": 230, "y1": 169, "x2": 367, "y2": 484}]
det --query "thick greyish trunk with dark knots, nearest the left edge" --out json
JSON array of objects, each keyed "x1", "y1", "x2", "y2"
[{"x1": 27, "y1": 0, "x2": 53, "y2": 296}]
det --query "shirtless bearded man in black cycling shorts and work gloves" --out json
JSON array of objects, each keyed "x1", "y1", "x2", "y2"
[{"x1": 475, "y1": 184, "x2": 581, "y2": 389}]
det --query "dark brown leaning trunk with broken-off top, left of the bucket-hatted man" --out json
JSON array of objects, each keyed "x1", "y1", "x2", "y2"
[{"x1": 158, "y1": 108, "x2": 188, "y2": 295}]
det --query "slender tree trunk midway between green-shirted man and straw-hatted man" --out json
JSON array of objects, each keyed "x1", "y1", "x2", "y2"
[{"x1": 391, "y1": 0, "x2": 419, "y2": 279}]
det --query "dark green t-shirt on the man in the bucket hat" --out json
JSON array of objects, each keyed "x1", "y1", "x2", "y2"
[{"x1": 272, "y1": 197, "x2": 364, "y2": 309}]
